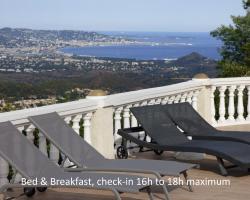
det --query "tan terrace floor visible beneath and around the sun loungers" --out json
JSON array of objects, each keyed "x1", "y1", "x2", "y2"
[{"x1": 2, "y1": 125, "x2": 250, "y2": 200}]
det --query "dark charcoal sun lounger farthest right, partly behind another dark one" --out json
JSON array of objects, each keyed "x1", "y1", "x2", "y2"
[{"x1": 164, "y1": 103, "x2": 250, "y2": 144}]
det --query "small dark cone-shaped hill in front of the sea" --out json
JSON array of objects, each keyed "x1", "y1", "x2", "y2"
[{"x1": 169, "y1": 52, "x2": 217, "y2": 67}]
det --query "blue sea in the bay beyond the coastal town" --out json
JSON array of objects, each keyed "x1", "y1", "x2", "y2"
[{"x1": 60, "y1": 32, "x2": 222, "y2": 60}]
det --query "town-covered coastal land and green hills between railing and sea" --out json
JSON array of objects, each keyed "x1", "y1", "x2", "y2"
[{"x1": 0, "y1": 28, "x2": 217, "y2": 111}]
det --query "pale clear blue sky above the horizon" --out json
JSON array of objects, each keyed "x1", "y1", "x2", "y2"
[{"x1": 0, "y1": 0, "x2": 245, "y2": 32}]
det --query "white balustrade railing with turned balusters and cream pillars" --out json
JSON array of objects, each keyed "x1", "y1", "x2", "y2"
[{"x1": 0, "y1": 77, "x2": 250, "y2": 185}]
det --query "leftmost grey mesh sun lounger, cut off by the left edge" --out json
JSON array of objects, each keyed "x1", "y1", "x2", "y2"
[{"x1": 0, "y1": 122, "x2": 168, "y2": 199}]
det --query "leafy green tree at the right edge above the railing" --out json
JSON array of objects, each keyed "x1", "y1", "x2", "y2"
[{"x1": 211, "y1": 0, "x2": 250, "y2": 76}]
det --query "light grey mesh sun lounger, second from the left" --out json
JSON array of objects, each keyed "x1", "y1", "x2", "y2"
[{"x1": 29, "y1": 113, "x2": 195, "y2": 190}]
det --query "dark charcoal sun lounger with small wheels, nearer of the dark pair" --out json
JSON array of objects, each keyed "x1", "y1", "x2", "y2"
[{"x1": 118, "y1": 105, "x2": 250, "y2": 175}]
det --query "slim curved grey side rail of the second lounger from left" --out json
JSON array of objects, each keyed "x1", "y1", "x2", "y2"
[{"x1": 65, "y1": 168, "x2": 162, "y2": 180}]
